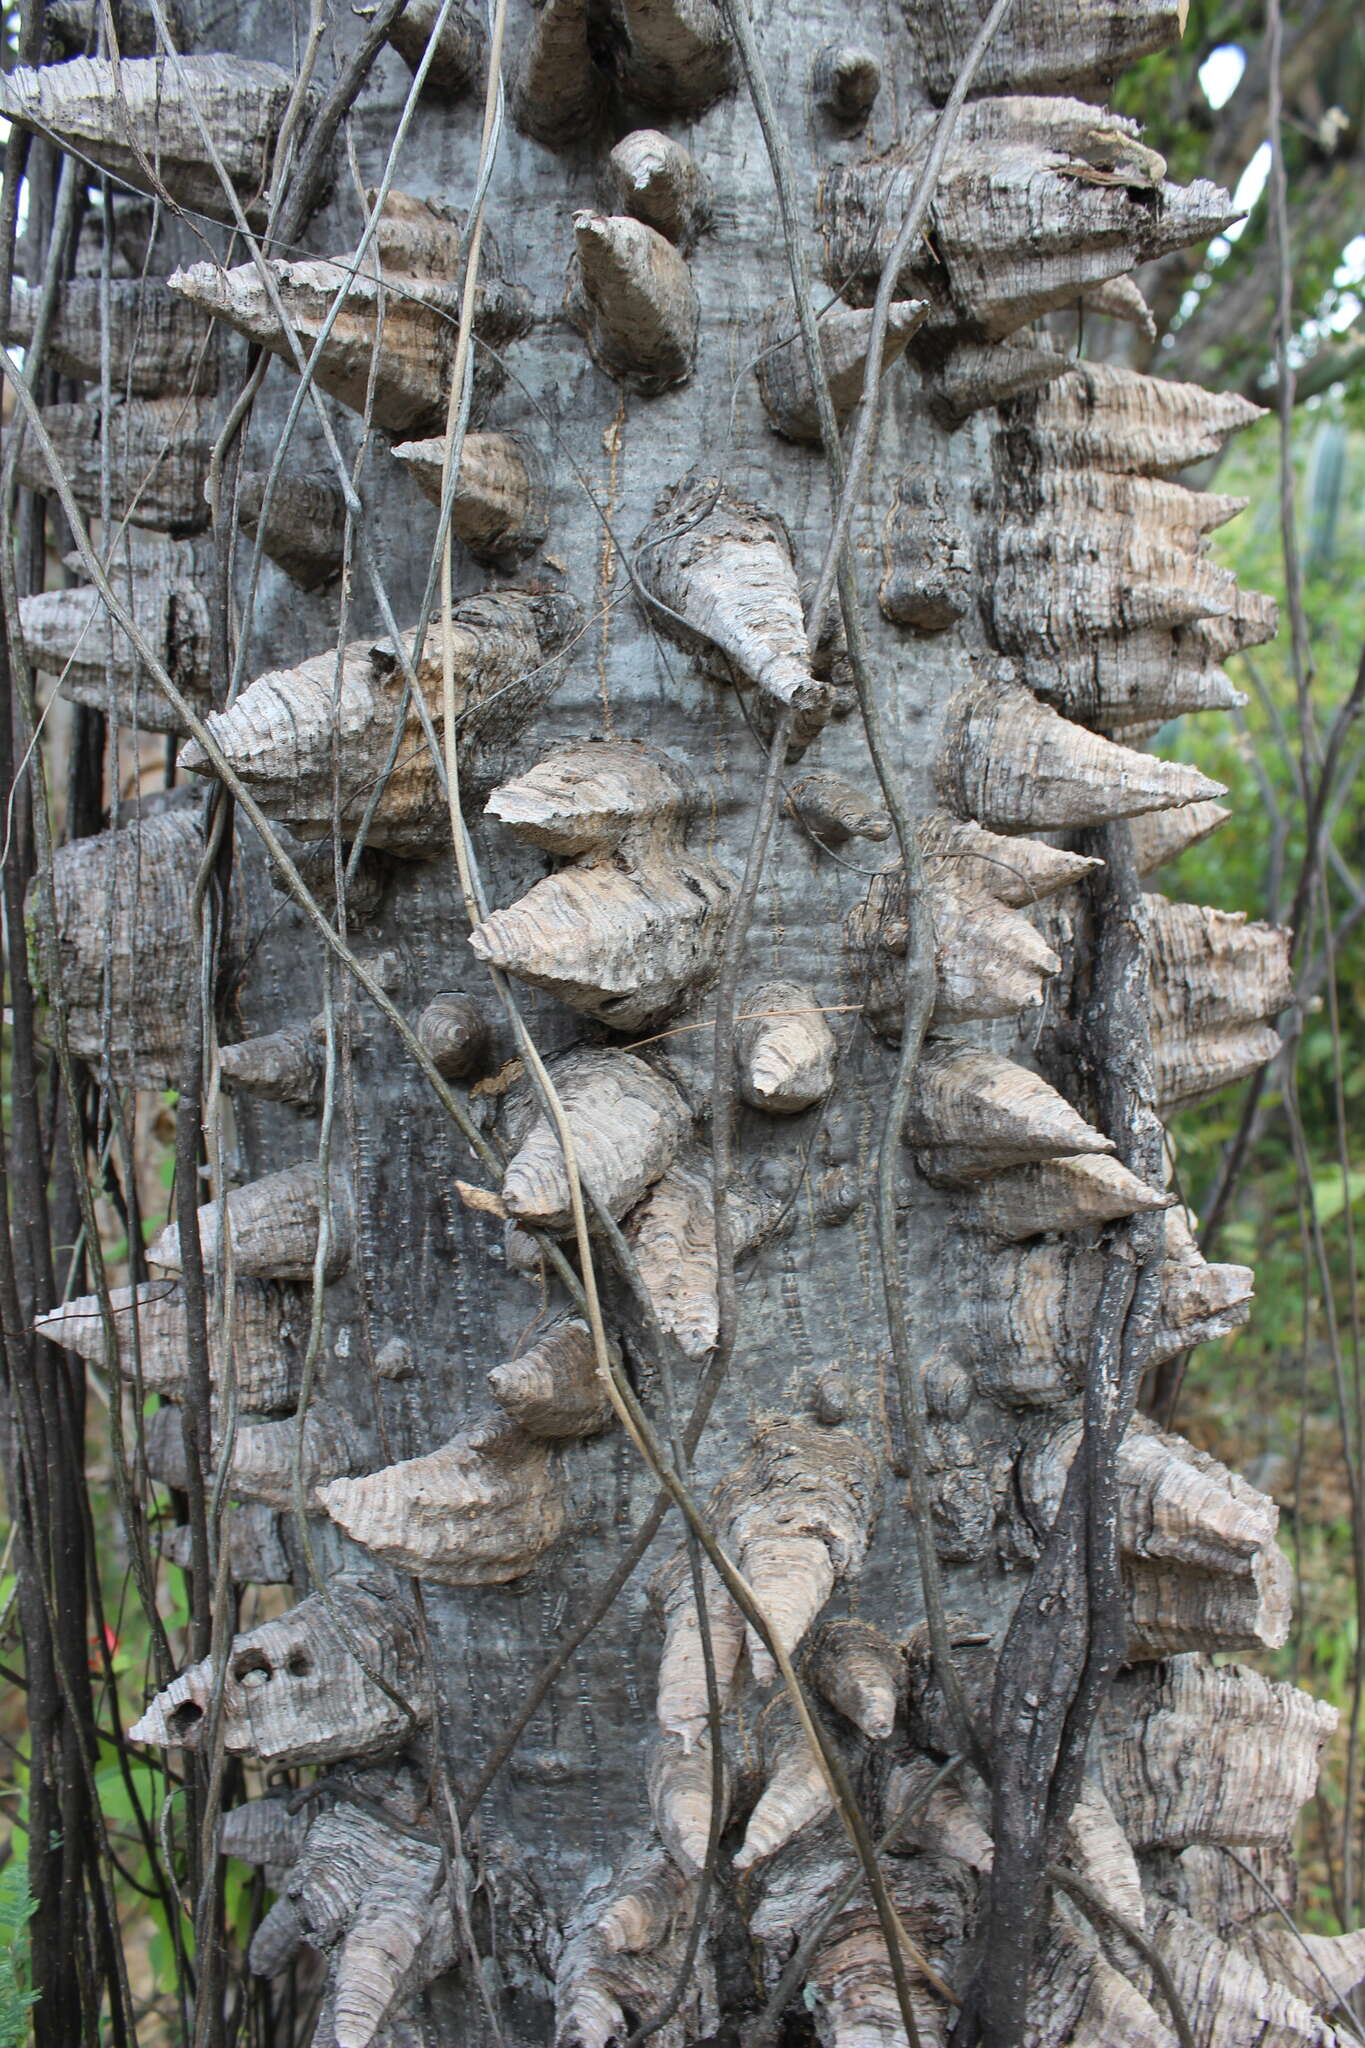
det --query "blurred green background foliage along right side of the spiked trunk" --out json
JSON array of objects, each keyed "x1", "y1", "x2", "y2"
[{"x1": 1154, "y1": 393, "x2": 1365, "y2": 1931}]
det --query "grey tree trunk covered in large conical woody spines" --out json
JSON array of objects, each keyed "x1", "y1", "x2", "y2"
[{"x1": 0, "y1": 0, "x2": 1363, "y2": 2048}]
